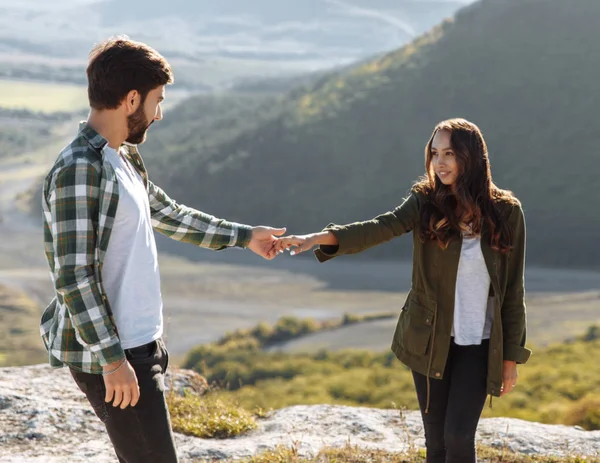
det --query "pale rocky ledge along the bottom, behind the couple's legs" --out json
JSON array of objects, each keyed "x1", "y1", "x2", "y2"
[{"x1": 0, "y1": 365, "x2": 600, "y2": 463}]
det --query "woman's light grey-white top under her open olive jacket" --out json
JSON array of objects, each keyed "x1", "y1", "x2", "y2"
[{"x1": 452, "y1": 237, "x2": 494, "y2": 346}]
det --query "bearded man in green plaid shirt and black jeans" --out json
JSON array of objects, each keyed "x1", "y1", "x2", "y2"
[{"x1": 41, "y1": 38, "x2": 285, "y2": 463}]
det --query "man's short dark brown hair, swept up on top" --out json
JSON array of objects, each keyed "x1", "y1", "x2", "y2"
[{"x1": 86, "y1": 36, "x2": 174, "y2": 109}]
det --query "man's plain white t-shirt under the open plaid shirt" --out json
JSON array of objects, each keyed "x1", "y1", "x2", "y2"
[{"x1": 102, "y1": 145, "x2": 163, "y2": 349}]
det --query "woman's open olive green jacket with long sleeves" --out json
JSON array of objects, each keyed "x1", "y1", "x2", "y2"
[{"x1": 315, "y1": 191, "x2": 531, "y2": 396}]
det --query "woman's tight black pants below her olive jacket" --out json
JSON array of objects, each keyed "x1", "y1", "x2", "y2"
[{"x1": 413, "y1": 340, "x2": 489, "y2": 463}]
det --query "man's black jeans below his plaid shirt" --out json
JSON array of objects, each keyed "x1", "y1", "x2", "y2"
[{"x1": 71, "y1": 339, "x2": 178, "y2": 463}]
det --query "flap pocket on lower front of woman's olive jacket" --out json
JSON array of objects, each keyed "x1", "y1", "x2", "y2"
[{"x1": 396, "y1": 299, "x2": 435, "y2": 355}]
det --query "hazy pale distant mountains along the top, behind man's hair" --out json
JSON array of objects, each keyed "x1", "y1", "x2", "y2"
[{"x1": 0, "y1": 0, "x2": 472, "y2": 90}]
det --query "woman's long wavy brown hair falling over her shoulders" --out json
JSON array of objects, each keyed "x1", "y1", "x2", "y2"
[{"x1": 414, "y1": 119, "x2": 518, "y2": 252}]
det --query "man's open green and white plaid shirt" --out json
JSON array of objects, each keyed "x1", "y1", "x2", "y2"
[{"x1": 40, "y1": 123, "x2": 251, "y2": 374}]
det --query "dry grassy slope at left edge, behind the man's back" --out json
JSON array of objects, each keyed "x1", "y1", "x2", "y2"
[{"x1": 0, "y1": 285, "x2": 46, "y2": 367}]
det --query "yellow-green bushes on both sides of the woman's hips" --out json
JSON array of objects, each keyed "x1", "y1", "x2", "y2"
[{"x1": 183, "y1": 318, "x2": 600, "y2": 429}]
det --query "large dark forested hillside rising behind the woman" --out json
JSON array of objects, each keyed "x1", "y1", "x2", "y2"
[{"x1": 143, "y1": 0, "x2": 600, "y2": 268}]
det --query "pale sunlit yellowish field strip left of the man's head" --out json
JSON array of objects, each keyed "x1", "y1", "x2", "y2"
[{"x1": 0, "y1": 79, "x2": 87, "y2": 113}]
